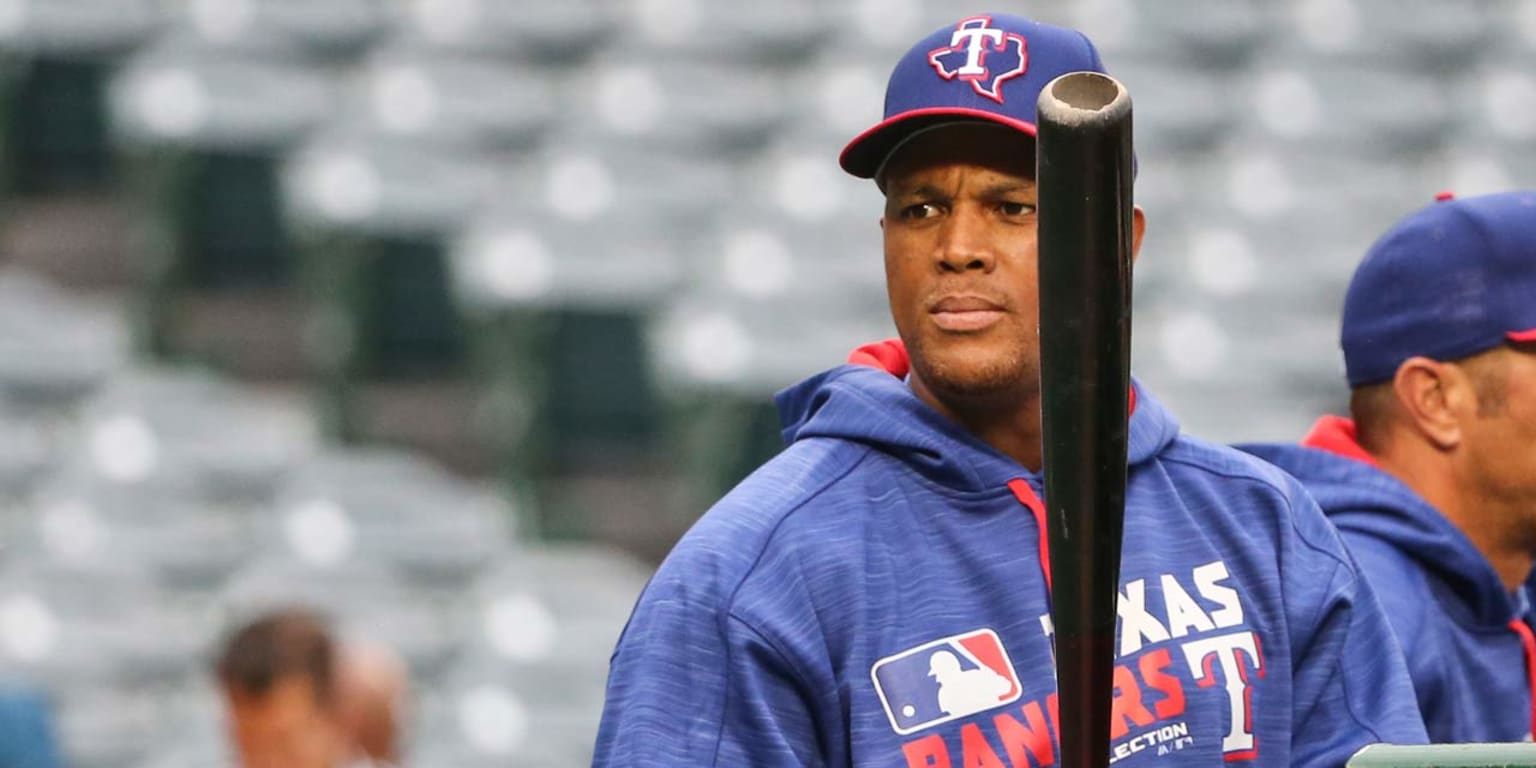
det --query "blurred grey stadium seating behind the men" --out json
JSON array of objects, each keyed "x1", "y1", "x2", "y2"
[{"x1": 0, "y1": 0, "x2": 1536, "y2": 768}]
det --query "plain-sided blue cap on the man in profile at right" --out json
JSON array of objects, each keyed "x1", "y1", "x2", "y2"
[{"x1": 1339, "y1": 189, "x2": 1536, "y2": 387}]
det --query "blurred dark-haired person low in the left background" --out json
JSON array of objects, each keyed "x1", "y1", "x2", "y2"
[{"x1": 217, "y1": 610, "x2": 406, "y2": 768}]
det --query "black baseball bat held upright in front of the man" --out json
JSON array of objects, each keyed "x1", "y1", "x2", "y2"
[{"x1": 1035, "y1": 72, "x2": 1135, "y2": 768}]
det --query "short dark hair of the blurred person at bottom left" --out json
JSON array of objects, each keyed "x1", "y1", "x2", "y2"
[{"x1": 214, "y1": 608, "x2": 336, "y2": 703}]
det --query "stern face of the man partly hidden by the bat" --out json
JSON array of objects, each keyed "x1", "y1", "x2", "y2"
[{"x1": 882, "y1": 123, "x2": 1040, "y2": 407}]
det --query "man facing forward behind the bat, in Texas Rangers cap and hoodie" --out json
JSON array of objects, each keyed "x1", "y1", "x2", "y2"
[{"x1": 596, "y1": 15, "x2": 1424, "y2": 768}]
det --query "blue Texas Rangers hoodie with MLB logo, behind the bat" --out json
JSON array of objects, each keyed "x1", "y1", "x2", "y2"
[{"x1": 594, "y1": 354, "x2": 1424, "y2": 768}]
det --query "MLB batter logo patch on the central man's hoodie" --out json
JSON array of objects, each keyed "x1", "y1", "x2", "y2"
[{"x1": 869, "y1": 630, "x2": 1023, "y2": 736}]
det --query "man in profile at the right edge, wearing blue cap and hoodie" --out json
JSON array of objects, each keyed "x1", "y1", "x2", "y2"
[{"x1": 1247, "y1": 190, "x2": 1536, "y2": 742}]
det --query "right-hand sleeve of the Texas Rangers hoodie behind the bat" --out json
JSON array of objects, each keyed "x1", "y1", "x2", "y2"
[{"x1": 1292, "y1": 496, "x2": 1427, "y2": 768}]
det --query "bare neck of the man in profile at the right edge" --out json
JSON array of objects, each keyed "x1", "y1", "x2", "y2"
[{"x1": 1375, "y1": 452, "x2": 1536, "y2": 591}]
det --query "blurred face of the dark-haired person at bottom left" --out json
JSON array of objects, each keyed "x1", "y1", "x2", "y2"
[{"x1": 226, "y1": 676, "x2": 346, "y2": 768}]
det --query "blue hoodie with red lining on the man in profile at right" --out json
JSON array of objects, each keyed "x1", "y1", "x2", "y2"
[{"x1": 1243, "y1": 416, "x2": 1536, "y2": 742}]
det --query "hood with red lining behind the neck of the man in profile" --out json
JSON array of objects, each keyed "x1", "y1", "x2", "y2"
[{"x1": 1238, "y1": 416, "x2": 1518, "y2": 627}]
